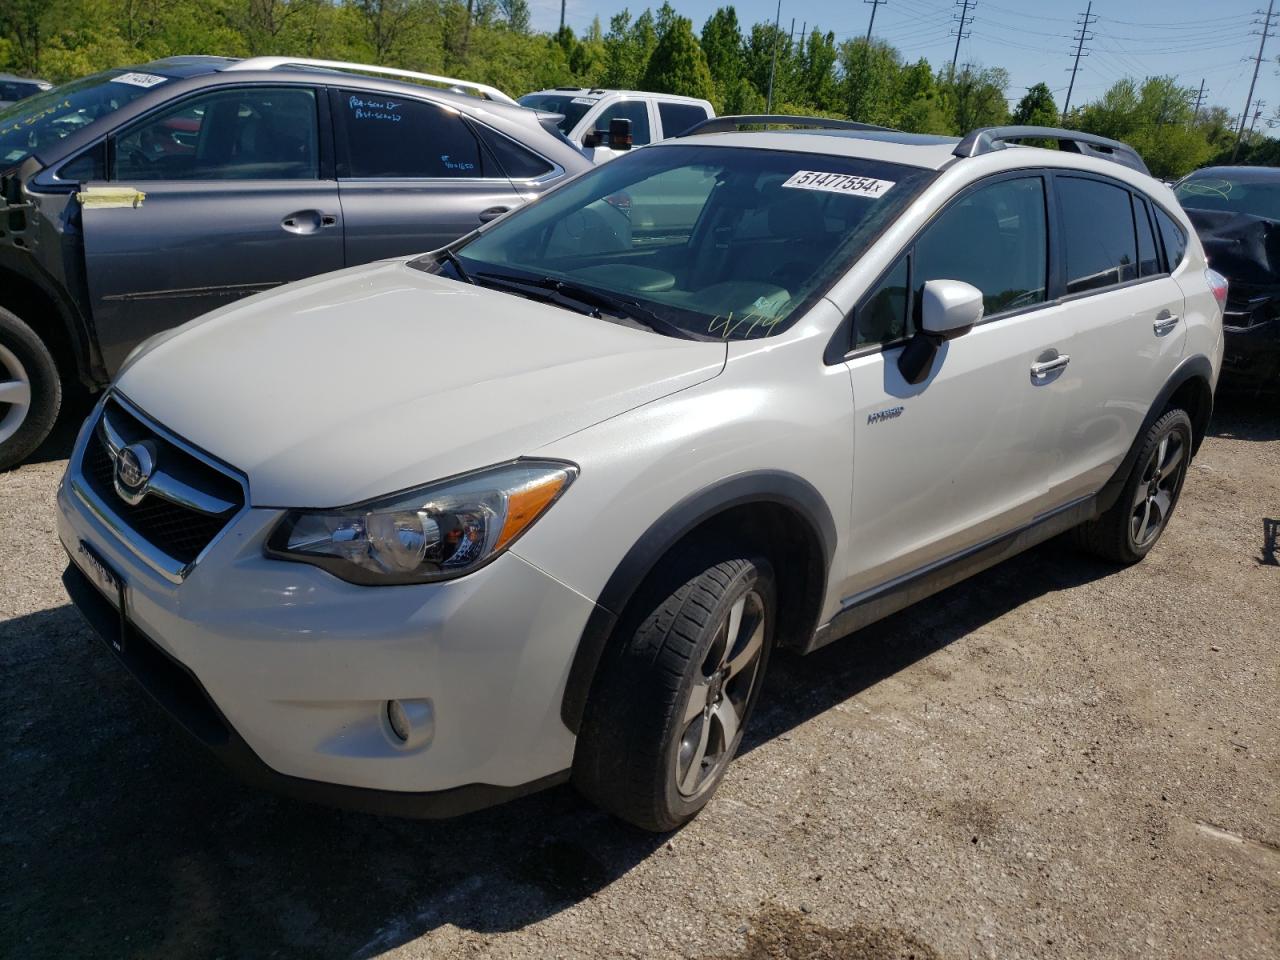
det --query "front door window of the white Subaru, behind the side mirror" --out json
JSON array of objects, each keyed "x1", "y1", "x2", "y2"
[{"x1": 911, "y1": 177, "x2": 1048, "y2": 323}]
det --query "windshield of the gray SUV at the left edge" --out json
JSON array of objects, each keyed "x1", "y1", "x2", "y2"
[{"x1": 0, "y1": 70, "x2": 168, "y2": 166}]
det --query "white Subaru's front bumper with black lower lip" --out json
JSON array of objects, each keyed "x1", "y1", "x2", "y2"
[{"x1": 58, "y1": 484, "x2": 594, "y2": 817}]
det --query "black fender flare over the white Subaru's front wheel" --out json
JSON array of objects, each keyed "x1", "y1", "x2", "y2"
[{"x1": 561, "y1": 470, "x2": 837, "y2": 733}]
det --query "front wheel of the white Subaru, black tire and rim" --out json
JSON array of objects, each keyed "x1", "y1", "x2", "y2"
[{"x1": 573, "y1": 548, "x2": 777, "y2": 832}]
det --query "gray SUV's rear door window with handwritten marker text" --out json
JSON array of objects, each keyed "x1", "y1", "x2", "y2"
[{"x1": 337, "y1": 90, "x2": 481, "y2": 179}]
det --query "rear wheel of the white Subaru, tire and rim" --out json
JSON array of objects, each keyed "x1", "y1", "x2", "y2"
[{"x1": 1073, "y1": 408, "x2": 1194, "y2": 564}]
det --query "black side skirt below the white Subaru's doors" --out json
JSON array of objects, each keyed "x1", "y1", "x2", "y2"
[{"x1": 803, "y1": 495, "x2": 1100, "y2": 653}]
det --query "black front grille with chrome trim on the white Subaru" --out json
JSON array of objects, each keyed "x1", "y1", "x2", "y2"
[{"x1": 79, "y1": 397, "x2": 244, "y2": 573}]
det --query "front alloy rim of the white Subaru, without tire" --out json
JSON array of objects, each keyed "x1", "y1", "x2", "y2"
[{"x1": 676, "y1": 590, "x2": 765, "y2": 797}]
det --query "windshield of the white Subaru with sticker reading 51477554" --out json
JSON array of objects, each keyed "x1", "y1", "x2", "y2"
[{"x1": 430, "y1": 145, "x2": 933, "y2": 339}]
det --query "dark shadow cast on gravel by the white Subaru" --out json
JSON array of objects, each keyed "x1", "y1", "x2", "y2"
[{"x1": 0, "y1": 544, "x2": 1108, "y2": 957}]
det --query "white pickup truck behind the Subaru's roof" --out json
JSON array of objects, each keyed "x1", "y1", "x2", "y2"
[{"x1": 518, "y1": 87, "x2": 716, "y2": 164}]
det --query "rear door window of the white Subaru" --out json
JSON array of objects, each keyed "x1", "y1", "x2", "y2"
[{"x1": 1056, "y1": 177, "x2": 1138, "y2": 294}]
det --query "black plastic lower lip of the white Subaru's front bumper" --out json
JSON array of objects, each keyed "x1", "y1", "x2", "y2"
[{"x1": 63, "y1": 563, "x2": 568, "y2": 819}]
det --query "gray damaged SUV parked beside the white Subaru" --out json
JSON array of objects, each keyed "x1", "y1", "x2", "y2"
[{"x1": 0, "y1": 56, "x2": 591, "y2": 468}]
